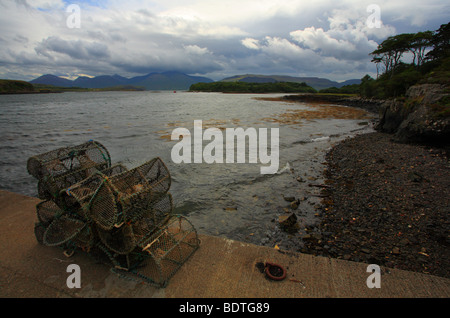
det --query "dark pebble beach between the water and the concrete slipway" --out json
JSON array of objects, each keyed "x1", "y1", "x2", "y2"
[{"x1": 302, "y1": 132, "x2": 450, "y2": 278}]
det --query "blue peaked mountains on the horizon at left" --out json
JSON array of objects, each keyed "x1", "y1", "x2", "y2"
[{"x1": 30, "y1": 71, "x2": 213, "y2": 90}]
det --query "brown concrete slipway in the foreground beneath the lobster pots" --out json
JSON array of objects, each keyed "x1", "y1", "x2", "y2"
[{"x1": 0, "y1": 190, "x2": 450, "y2": 298}]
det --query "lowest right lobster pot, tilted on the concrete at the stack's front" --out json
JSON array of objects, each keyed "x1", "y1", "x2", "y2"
[{"x1": 120, "y1": 215, "x2": 199, "y2": 287}]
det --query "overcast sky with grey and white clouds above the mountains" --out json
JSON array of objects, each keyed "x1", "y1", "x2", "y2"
[{"x1": 0, "y1": 0, "x2": 450, "y2": 81}]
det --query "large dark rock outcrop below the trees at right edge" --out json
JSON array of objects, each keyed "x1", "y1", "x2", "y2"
[{"x1": 376, "y1": 84, "x2": 450, "y2": 143}]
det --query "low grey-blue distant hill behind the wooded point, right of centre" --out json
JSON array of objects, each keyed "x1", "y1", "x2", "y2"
[{"x1": 222, "y1": 74, "x2": 361, "y2": 90}]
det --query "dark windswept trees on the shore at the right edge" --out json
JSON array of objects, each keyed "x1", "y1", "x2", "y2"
[{"x1": 360, "y1": 23, "x2": 450, "y2": 98}]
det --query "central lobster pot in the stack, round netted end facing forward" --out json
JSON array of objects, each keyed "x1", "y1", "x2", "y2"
[{"x1": 63, "y1": 158, "x2": 170, "y2": 231}]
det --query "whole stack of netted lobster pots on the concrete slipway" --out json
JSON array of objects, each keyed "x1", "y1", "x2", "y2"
[{"x1": 27, "y1": 141, "x2": 199, "y2": 287}]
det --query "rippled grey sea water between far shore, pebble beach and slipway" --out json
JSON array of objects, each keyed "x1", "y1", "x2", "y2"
[{"x1": 0, "y1": 91, "x2": 373, "y2": 248}]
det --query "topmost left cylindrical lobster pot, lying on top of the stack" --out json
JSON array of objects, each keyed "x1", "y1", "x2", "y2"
[{"x1": 27, "y1": 141, "x2": 111, "y2": 180}]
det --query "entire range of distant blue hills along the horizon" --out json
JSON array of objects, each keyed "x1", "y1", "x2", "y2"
[{"x1": 30, "y1": 71, "x2": 361, "y2": 90}]
